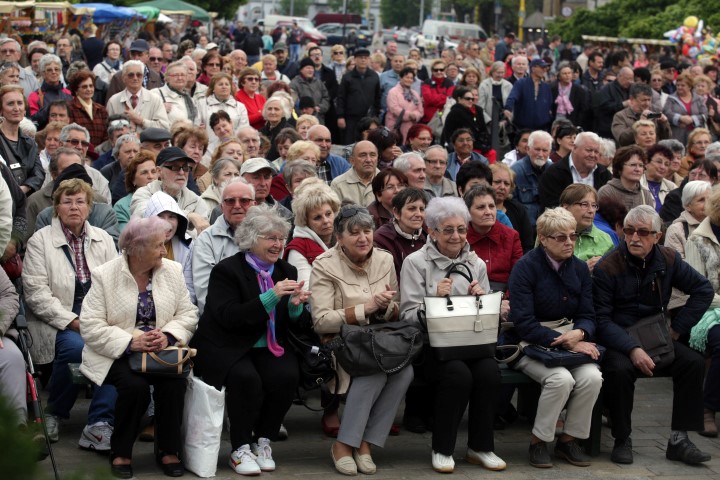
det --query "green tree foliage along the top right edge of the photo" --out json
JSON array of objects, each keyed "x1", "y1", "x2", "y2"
[{"x1": 548, "y1": 0, "x2": 720, "y2": 43}]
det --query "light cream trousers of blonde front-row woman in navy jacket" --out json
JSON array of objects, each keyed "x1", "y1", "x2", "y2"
[{"x1": 515, "y1": 356, "x2": 602, "y2": 442}]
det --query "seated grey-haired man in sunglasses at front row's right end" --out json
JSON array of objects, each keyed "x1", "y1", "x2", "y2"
[{"x1": 593, "y1": 205, "x2": 714, "y2": 465}]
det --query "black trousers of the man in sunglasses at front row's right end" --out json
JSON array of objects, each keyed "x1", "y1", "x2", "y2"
[{"x1": 602, "y1": 342, "x2": 705, "y2": 441}]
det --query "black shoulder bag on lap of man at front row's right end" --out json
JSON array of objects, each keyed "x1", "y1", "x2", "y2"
[{"x1": 625, "y1": 276, "x2": 675, "y2": 369}]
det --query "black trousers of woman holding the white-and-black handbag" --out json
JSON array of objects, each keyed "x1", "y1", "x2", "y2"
[{"x1": 425, "y1": 352, "x2": 500, "y2": 455}]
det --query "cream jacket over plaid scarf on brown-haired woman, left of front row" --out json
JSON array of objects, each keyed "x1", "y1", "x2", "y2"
[{"x1": 22, "y1": 217, "x2": 116, "y2": 364}]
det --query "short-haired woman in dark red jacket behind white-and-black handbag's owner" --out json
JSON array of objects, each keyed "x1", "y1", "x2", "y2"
[{"x1": 463, "y1": 185, "x2": 523, "y2": 292}]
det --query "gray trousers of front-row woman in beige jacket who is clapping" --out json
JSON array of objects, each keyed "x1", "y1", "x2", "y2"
[{"x1": 338, "y1": 366, "x2": 413, "y2": 448}]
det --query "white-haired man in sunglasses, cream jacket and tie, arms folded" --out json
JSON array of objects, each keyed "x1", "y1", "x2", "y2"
[{"x1": 107, "y1": 60, "x2": 170, "y2": 133}]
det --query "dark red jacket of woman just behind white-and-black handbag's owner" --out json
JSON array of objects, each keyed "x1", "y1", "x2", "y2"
[{"x1": 467, "y1": 221, "x2": 522, "y2": 283}]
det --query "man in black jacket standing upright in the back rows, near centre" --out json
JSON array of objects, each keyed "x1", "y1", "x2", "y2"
[{"x1": 336, "y1": 48, "x2": 380, "y2": 145}]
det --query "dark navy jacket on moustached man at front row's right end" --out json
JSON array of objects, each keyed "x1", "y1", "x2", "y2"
[{"x1": 592, "y1": 242, "x2": 714, "y2": 355}]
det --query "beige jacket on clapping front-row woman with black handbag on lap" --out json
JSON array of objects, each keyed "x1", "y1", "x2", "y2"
[{"x1": 310, "y1": 246, "x2": 398, "y2": 393}]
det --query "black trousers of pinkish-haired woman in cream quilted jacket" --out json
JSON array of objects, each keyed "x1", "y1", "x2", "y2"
[{"x1": 104, "y1": 357, "x2": 187, "y2": 458}]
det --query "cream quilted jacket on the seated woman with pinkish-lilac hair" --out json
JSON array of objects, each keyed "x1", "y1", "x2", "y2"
[{"x1": 80, "y1": 256, "x2": 198, "y2": 385}]
